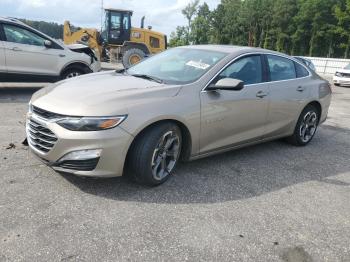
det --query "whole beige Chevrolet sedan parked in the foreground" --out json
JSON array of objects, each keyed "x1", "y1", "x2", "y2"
[{"x1": 26, "y1": 46, "x2": 331, "y2": 185}]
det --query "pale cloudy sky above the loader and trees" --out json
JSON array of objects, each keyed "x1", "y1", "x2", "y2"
[{"x1": 0, "y1": 0, "x2": 220, "y2": 35}]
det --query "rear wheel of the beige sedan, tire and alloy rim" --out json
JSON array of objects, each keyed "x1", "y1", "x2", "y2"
[{"x1": 287, "y1": 105, "x2": 320, "y2": 146}]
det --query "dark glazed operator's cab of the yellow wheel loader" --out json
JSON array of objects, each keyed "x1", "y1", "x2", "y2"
[{"x1": 102, "y1": 9, "x2": 133, "y2": 45}]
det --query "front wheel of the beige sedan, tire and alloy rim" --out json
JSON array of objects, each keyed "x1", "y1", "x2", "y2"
[{"x1": 126, "y1": 123, "x2": 182, "y2": 186}]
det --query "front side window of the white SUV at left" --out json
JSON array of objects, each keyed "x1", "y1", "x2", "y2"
[{"x1": 3, "y1": 25, "x2": 45, "y2": 46}]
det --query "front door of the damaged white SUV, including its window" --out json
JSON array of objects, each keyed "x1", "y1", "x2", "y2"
[{"x1": 3, "y1": 24, "x2": 63, "y2": 75}]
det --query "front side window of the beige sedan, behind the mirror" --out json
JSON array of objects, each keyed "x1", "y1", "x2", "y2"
[{"x1": 216, "y1": 55, "x2": 263, "y2": 85}]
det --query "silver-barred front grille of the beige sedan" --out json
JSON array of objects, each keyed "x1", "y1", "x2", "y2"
[{"x1": 27, "y1": 119, "x2": 58, "y2": 153}]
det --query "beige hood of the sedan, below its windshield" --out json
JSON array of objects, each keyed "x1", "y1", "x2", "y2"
[{"x1": 31, "y1": 71, "x2": 181, "y2": 116}]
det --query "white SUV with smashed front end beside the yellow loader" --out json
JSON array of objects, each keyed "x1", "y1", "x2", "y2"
[{"x1": 0, "y1": 17, "x2": 101, "y2": 82}]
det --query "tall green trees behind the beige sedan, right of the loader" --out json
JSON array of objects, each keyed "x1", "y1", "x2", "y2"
[{"x1": 169, "y1": 0, "x2": 350, "y2": 58}]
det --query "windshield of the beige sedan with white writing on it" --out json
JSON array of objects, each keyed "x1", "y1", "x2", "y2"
[{"x1": 127, "y1": 48, "x2": 227, "y2": 84}]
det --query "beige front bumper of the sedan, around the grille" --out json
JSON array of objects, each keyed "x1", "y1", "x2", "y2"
[{"x1": 26, "y1": 113, "x2": 133, "y2": 177}]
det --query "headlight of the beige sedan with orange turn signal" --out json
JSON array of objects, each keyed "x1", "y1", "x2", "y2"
[{"x1": 56, "y1": 116, "x2": 126, "y2": 131}]
